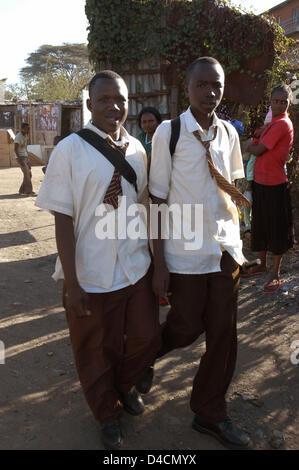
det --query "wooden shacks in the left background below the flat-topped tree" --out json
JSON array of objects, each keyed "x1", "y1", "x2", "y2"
[{"x1": 0, "y1": 101, "x2": 82, "y2": 166}]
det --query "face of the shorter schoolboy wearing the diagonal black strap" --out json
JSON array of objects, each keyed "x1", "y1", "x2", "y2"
[{"x1": 87, "y1": 78, "x2": 128, "y2": 136}]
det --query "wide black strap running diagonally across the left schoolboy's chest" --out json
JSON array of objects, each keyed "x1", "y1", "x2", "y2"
[{"x1": 76, "y1": 129, "x2": 137, "y2": 193}]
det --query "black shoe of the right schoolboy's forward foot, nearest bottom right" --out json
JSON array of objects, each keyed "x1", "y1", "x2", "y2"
[{"x1": 192, "y1": 415, "x2": 250, "y2": 449}]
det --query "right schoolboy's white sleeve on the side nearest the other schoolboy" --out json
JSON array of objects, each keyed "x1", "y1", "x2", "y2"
[{"x1": 149, "y1": 121, "x2": 172, "y2": 199}]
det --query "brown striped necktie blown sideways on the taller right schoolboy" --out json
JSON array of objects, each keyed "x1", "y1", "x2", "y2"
[{"x1": 193, "y1": 127, "x2": 251, "y2": 207}]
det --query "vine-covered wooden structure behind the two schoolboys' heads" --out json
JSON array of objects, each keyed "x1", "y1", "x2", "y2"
[{"x1": 85, "y1": 0, "x2": 278, "y2": 135}]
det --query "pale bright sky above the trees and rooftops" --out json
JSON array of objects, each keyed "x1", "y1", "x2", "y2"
[{"x1": 0, "y1": 0, "x2": 283, "y2": 84}]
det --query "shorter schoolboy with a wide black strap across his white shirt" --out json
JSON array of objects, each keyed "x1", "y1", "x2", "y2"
[{"x1": 36, "y1": 71, "x2": 160, "y2": 449}]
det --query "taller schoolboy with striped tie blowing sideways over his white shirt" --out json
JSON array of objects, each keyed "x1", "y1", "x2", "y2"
[{"x1": 149, "y1": 57, "x2": 248, "y2": 448}]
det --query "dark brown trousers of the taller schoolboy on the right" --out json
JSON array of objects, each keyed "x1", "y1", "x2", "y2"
[{"x1": 159, "y1": 252, "x2": 239, "y2": 423}]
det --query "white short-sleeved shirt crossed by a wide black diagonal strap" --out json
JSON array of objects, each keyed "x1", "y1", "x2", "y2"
[{"x1": 36, "y1": 123, "x2": 150, "y2": 292}]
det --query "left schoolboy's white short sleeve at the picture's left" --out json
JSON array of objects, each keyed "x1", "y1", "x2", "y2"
[{"x1": 35, "y1": 141, "x2": 74, "y2": 217}]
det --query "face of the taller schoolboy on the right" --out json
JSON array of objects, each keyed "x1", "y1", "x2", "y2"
[{"x1": 186, "y1": 64, "x2": 224, "y2": 116}]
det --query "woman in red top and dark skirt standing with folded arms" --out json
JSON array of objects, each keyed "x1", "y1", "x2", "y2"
[{"x1": 248, "y1": 84, "x2": 294, "y2": 293}]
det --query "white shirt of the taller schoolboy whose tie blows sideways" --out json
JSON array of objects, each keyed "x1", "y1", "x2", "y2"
[{"x1": 149, "y1": 108, "x2": 245, "y2": 274}]
